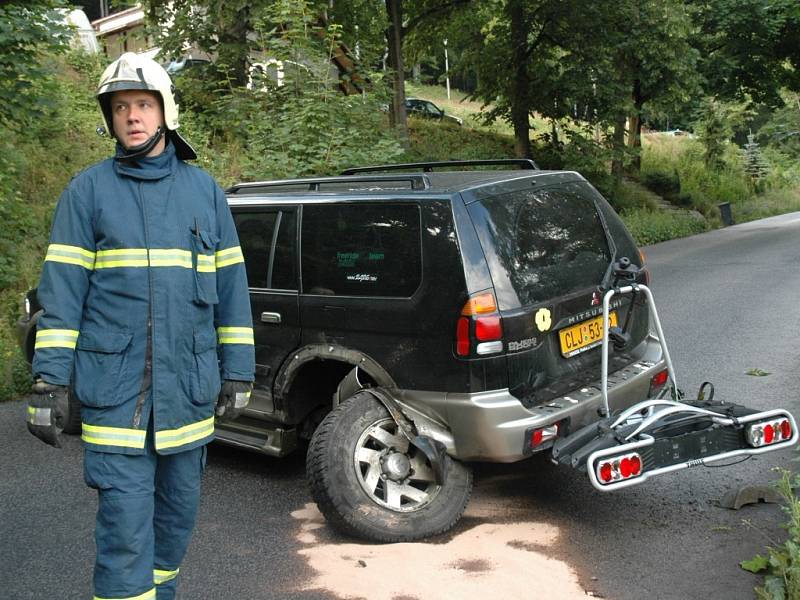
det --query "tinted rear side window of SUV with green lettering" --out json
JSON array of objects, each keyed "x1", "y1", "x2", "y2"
[{"x1": 302, "y1": 204, "x2": 422, "y2": 297}]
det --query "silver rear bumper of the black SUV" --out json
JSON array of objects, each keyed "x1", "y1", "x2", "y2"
[{"x1": 399, "y1": 335, "x2": 666, "y2": 462}]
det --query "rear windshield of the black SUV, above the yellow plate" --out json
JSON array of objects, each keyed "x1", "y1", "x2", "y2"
[{"x1": 469, "y1": 184, "x2": 611, "y2": 309}]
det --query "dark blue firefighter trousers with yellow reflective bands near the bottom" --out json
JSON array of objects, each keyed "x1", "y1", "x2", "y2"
[{"x1": 84, "y1": 419, "x2": 206, "y2": 600}]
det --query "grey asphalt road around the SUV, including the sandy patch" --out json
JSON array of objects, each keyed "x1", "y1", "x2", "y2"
[{"x1": 0, "y1": 214, "x2": 800, "y2": 600}]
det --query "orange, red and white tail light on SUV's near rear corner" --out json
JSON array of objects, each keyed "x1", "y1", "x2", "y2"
[{"x1": 456, "y1": 292, "x2": 503, "y2": 356}]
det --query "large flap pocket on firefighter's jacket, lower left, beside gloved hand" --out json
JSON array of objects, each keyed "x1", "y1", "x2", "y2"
[{"x1": 75, "y1": 329, "x2": 133, "y2": 408}]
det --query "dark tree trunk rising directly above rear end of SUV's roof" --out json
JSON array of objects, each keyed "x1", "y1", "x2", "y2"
[{"x1": 506, "y1": 0, "x2": 531, "y2": 158}]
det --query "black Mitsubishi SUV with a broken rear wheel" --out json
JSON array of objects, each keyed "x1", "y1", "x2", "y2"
[{"x1": 15, "y1": 160, "x2": 666, "y2": 541}]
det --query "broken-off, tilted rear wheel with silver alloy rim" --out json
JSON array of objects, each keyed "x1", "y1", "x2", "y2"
[{"x1": 306, "y1": 392, "x2": 472, "y2": 542}]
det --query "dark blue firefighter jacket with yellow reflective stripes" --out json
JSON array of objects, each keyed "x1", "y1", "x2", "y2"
[{"x1": 33, "y1": 144, "x2": 254, "y2": 454}]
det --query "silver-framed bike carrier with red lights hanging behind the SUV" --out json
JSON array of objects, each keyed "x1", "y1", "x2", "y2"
[{"x1": 553, "y1": 283, "x2": 798, "y2": 492}]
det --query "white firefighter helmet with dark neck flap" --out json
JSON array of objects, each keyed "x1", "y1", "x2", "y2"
[{"x1": 96, "y1": 52, "x2": 197, "y2": 160}]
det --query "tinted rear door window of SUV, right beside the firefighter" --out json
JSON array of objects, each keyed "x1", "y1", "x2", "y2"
[{"x1": 233, "y1": 210, "x2": 297, "y2": 290}]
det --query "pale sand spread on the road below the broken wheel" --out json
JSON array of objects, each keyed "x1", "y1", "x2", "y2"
[{"x1": 292, "y1": 504, "x2": 591, "y2": 600}]
